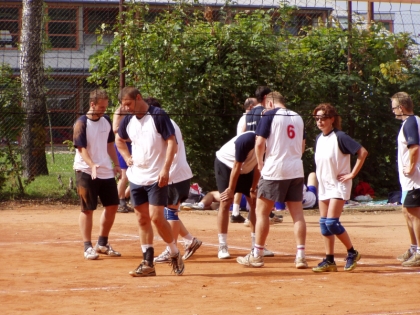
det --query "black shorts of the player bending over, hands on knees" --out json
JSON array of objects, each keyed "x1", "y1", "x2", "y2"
[{"x1": 214, "y1": 158, "x2": 254, "y2": 197}]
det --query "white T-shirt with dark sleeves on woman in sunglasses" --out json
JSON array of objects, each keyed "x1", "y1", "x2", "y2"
[{"x1": 315, "y1": 129, "x2": 362, "y2": 200}]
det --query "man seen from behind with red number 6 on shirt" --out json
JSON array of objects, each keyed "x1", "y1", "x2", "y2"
[{"x1": 237, "y1": 92, "x2": 308, "y2": 269}]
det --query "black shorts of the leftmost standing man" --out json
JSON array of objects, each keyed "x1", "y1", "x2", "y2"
[{"x1": 76, "y1": 171, "x2": 119, "y2": 211}]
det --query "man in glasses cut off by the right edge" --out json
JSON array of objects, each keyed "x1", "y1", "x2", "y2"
[{"x1": 391, "y1": 92, "x2": 420, "y2": 267}]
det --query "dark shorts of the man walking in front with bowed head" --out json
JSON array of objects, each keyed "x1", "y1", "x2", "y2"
[{"x1": 130, "y1": 182, "x2": 168, "y2": 207}]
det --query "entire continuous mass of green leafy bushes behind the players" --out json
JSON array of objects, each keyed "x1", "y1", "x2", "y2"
[{"x1": 89, "y1": 3, "x2": 419, "y2": 194}]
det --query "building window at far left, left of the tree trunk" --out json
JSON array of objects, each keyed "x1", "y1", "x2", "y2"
[{"x1": 0, "y1": 7, "x2": 20, "y2": 49}]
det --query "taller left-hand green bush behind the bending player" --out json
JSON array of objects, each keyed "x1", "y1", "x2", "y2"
[{"x1": 89, "y1": 4, "x2": 289, "y2": 189}]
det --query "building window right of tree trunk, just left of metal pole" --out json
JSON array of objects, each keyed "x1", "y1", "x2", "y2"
[{"x1": 83, "y1": 9, "x2": 118, "y2": 34}]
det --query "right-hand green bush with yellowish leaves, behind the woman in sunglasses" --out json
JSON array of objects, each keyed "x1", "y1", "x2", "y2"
[{"x1": 275, "y1": 21, "x2": 420, "y2": 196}]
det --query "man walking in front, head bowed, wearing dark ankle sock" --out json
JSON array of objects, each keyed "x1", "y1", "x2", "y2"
[{"x1": 116, "y1": 87, "x2": 184, "y2": 277}]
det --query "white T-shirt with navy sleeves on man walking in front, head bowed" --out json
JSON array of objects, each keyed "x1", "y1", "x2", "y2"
[{"x1": 118, "y1": 106, "x2": 175, "y2": 186}]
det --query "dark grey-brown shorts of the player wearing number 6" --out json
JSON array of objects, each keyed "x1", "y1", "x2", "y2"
[{"x1": 257, "y1": 177, "x2": 304, "y2": 202}]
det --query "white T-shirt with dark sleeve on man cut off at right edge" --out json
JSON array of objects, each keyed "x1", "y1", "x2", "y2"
[{"x1": 397, "y1": 116, "x2": 420, "y2": 191}]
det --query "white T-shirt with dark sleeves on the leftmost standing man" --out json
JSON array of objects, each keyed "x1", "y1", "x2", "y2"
[{"x1": 73, "y1": 115, "x2": 115, "y2": 179}]
